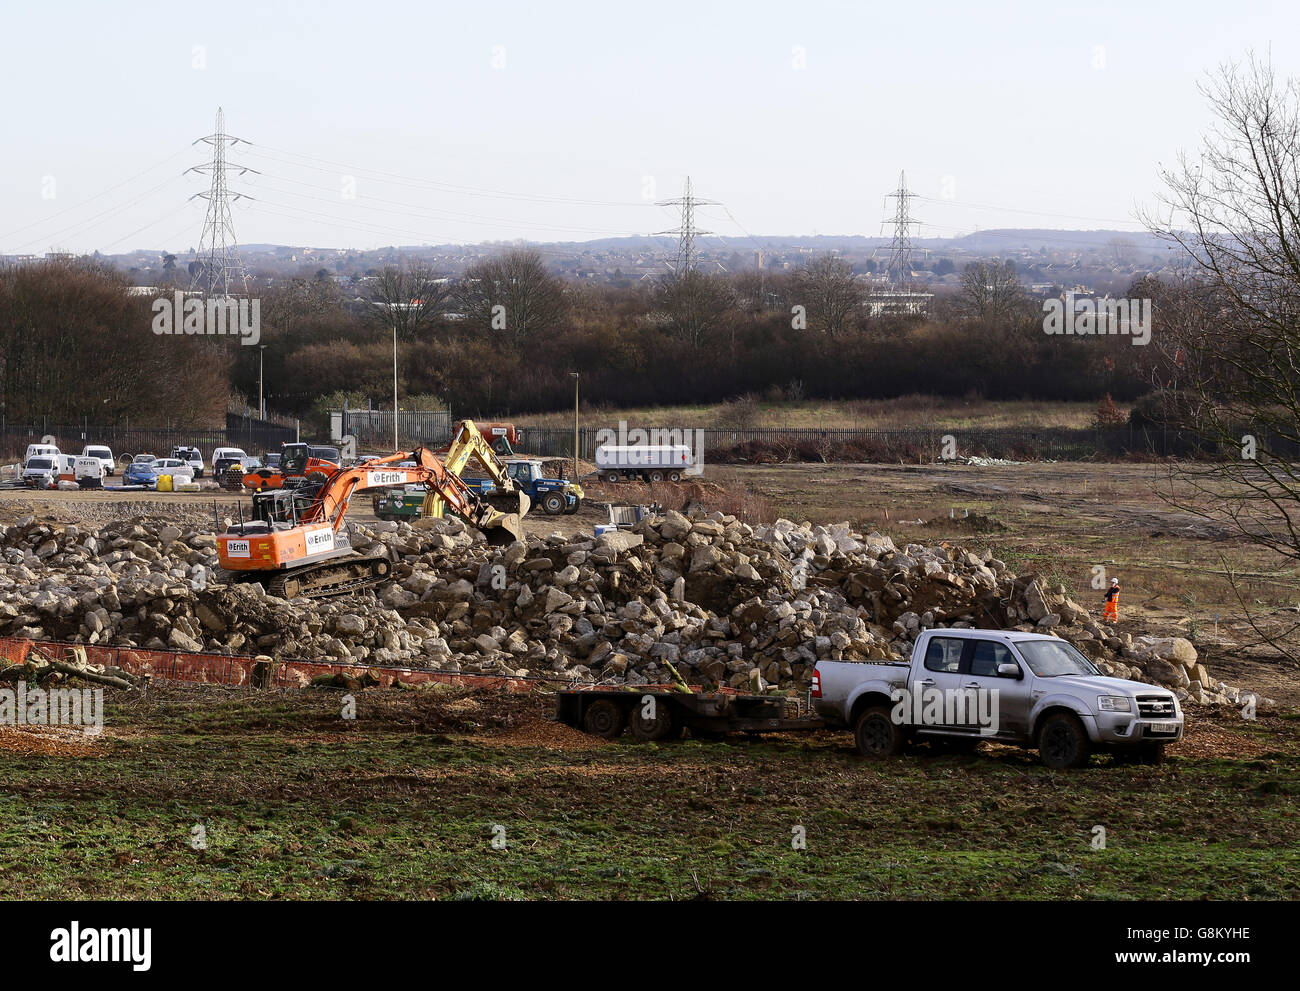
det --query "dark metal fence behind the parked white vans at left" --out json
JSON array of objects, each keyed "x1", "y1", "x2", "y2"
[{"x1": 0, "y1": 414, "x2": 298, "y2": 460}]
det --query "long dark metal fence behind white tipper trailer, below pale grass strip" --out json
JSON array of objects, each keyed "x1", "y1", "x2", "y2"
[{"x1": 519, "y1": 424, "x2": 1300, "y2": 463}]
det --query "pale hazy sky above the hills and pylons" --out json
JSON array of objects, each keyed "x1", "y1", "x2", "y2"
[{"x1": 0, "y1": 0, "x2": 1300, "y2": 254}]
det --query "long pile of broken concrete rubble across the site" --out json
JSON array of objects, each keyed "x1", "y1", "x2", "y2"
[{"x1": 0, "y1": 511, "x2": 1268, "y2": 702}]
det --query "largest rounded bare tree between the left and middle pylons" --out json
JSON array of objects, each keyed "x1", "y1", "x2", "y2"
[{"x1": 455, "y1": 251, "x2": 568, "y2": 346}]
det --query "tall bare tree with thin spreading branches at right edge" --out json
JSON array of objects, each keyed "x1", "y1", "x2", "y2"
[{"x1": 1147, "y1": 56, "x2": 1300, "y2": 658}]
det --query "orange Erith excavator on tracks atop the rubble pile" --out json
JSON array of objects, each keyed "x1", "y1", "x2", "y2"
[{"x1": 217, "y1": 447, "x2": 529, "y2": 598}]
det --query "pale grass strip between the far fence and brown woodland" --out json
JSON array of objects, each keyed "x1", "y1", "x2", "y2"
[{"x1": 517, "y1": 395, "x2": 1107, "y2": 429}]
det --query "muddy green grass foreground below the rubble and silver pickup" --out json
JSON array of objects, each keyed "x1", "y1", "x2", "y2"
[{"x1": 0, "y1": 685, "x2": 1300, "y2": 900}]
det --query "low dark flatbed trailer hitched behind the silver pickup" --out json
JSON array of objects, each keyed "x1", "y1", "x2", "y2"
[{"x1": 555, "y1": 685, "x2": 826, "y2": 743}]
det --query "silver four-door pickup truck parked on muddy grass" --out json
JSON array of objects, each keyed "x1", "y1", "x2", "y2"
[{"x1": 813, "y1": 629, "x2": 1183, "y2": 767}]
